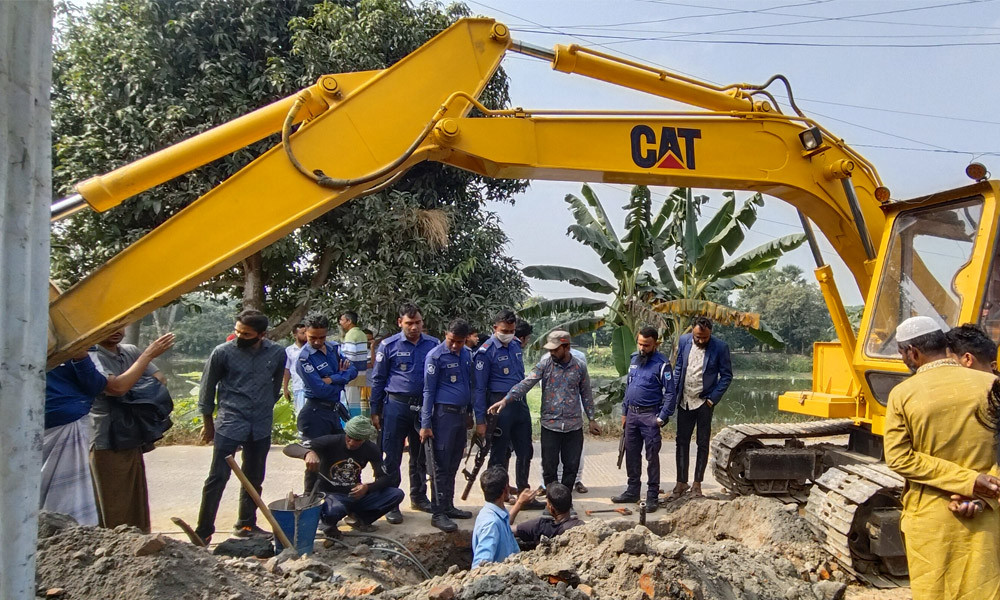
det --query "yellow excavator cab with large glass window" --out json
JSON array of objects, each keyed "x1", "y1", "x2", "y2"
[{"x1": 854, "y1": 182, "x2": 1000, "y2": 420}]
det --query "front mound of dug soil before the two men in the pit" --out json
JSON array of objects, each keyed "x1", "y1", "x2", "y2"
[{"x1": 352, "y1": 520, "x2": 846, "y2": 600}]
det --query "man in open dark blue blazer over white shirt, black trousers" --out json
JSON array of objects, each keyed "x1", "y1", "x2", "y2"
[{"x1": 668, "y1": 317, "x2": 733, "y2": 500}]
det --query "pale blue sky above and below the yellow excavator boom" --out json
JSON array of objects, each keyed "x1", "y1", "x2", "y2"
[{"x1": 466, "y1": 0, "x2": 1000, "y2": 304}]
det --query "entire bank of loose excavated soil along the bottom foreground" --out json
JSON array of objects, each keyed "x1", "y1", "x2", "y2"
[{"x1": 37, "y1": 497, "x2": 910, "y2": 600}]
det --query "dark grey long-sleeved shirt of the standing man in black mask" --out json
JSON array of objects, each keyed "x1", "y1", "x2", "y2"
[{"x1": 198, "y1": 339, "x2": 286, "y2": 442}]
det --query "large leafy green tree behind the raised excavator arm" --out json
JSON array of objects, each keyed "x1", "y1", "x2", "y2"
[{"x1": 53, "y1": 0, "x2": 525, "y2": 337}]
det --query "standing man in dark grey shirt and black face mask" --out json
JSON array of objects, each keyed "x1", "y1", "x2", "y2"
[{"x1": 195, "y1": 310, "x2": 286, "y2": 542}]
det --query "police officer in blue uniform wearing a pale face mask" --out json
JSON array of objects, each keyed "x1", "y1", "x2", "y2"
[{"x1": 472, "y1": 310, "x2": 545, "y2": 509}]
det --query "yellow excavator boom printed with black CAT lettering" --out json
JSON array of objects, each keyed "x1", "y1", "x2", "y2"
[{"x1": 428, "y1": 111, "x2": 885, "y2": 294}]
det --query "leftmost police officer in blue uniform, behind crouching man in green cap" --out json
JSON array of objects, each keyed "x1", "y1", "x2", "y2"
[{"x1": 295, "y1": 315, "x2": 358, "y2": 440}]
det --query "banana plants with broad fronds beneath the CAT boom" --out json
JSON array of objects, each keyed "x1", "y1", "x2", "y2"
[{"x1": 523, "y1": 184, "x2": 805, "y2": 375}]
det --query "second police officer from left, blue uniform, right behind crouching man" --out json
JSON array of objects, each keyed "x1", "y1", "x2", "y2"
[{"x1": 370, "y1": 304, "x2": 438, "y2": 525}]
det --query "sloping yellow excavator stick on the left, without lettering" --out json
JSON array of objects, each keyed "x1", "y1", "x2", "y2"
[{"x1": 49, "y1": 19, "x2": 509, "y2": 366}]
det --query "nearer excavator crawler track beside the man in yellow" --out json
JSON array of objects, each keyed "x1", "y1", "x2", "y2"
[{"x1": 805, "y1": 463, "x2": 909, "y2": 588}]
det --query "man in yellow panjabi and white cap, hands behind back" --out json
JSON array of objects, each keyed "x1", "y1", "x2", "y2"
[{"x1": 884, "y1": 317, "x2": 1000, "y2": 600}]
